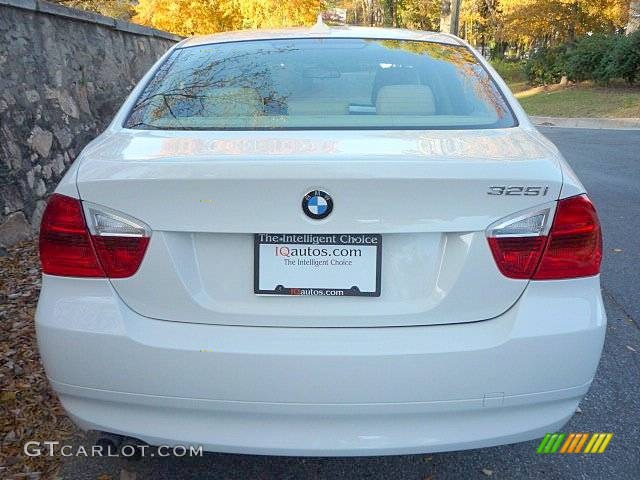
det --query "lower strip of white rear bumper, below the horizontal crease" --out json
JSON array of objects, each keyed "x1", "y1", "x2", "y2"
[{"x1": 51, "y1": 381, "x2": 589, "y2": 456}]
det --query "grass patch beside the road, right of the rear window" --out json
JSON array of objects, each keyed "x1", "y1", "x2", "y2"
[{"x1": 510, "y1": 83, "x2": 640, "y2": 118}]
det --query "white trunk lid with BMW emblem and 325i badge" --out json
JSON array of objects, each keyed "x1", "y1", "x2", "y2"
[{"x1": 78, "y1": 128, "x2": 562, "y2": 327}]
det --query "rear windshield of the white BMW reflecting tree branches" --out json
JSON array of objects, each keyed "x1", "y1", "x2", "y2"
[{"x1": 125, "y1": 38, "x2": 516, "y2": 130}]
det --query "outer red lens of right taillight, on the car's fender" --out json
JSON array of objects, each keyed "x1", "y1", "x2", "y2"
[{"x1": 533, "y1": 195, "x2": 602, "y2": 280}]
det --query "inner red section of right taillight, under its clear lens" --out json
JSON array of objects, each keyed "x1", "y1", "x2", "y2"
[{"x1": 489, "y1": 236, "x2": 547, "y2": 278}]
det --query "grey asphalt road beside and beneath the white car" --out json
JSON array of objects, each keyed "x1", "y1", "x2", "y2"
[{"x1": 60, "y1": 128, "x2": 640, "y2": 480}]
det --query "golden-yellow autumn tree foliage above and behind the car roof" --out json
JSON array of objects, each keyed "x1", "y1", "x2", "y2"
[{"x1": 52, "y1": 0, "x2": 630, "y2": 51}]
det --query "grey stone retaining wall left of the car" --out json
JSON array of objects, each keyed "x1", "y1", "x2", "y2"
[{"x1": 0, "y1": 0, "x2": 180, "y2": 247}]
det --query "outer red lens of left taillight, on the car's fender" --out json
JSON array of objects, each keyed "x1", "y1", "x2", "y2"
[{"x1": 40, "y1": 193, "x2": 105, "y2": 277}]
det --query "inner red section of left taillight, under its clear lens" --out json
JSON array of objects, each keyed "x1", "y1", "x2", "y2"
[{"x1": 91, "y1": 235, "x2": 149, "y2": 278}]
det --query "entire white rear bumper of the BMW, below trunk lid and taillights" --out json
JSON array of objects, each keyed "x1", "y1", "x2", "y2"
[{"x1": 36, "y1": 276, "x2": 606, "y2": 455}]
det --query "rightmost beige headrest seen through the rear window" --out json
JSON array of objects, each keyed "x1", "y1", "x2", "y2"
[{"x1": 376, "y1": 85, "x2": 436, "y2": 115}]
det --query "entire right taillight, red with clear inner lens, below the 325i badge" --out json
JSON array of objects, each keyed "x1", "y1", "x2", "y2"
[{"x1": 487, "y1": 195, "x2": 602, "y2": 280}]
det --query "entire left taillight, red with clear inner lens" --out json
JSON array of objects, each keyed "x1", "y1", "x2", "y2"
[{"x1": 40, "y1": 194, "x2": 151, "y2": 278}]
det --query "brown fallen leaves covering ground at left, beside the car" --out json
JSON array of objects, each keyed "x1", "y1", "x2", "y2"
[{"x1": 0, "y1": 241, "x2": 77, "y2": 480}]
